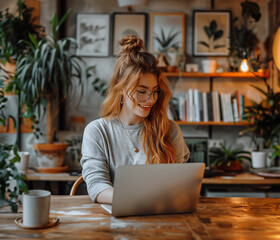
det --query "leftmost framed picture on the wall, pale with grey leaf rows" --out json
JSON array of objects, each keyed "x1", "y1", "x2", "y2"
[{"x1": 76, "y1": 13, "x2": 110, "y2": 57}]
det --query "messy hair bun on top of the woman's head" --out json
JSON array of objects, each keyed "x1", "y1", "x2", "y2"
[{"x1": 119, "y1": 35, "x2": 145, "y2": 53}]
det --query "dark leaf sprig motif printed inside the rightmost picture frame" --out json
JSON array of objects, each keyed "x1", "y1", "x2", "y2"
[{"x1": 198, "y1": 20, "x2": 225, "y2": 50}]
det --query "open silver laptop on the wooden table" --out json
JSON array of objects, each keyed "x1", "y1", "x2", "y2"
[{"x1": 101, "y1": 163, "x2": 205, "y2": 216}]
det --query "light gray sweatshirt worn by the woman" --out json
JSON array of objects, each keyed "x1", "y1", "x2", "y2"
[{"x1": 81, "y1": 118, "x2": 189, "y2": 202}]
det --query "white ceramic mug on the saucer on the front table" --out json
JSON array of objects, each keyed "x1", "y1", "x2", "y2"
[{"x1": 22, "y1": 190, "x2": 51, "y2": 227}]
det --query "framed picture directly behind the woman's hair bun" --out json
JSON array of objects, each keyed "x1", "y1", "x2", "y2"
[{"x1": 113, "y1": 13, "x2": 147, "y2": 56}]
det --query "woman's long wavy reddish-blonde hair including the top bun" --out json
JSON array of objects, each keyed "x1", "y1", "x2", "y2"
[{"x1": 101, "y1": 35, "x2": 176, "y2": 164}]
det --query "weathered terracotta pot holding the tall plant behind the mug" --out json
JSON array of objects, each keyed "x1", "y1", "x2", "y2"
[{"x1": 33, "y1": 143, "x2": 68, "y2": 168}]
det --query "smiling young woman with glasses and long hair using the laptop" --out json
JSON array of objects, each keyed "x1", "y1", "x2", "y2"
[{"x1": 81, "y1": 36, "x2": 189, "y2": 203}]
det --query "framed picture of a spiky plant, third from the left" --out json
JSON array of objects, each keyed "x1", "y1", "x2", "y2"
[{"x1": 150, "y1": 13, "x2": 186, "y2": 53}]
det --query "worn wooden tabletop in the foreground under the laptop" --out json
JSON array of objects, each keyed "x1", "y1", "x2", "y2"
[{"x1": 0, "y1": 196, "x2": 280, "y2": 240}]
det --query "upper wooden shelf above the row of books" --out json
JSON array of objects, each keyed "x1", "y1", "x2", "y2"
[{"x1": 164, "y1": 71, "x2": 269, "y2": 78}]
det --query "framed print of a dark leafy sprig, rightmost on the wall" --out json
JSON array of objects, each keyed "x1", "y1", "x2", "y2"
[{"x1": 193, "y1": 10, "x2": 231, "y2": 56}]
